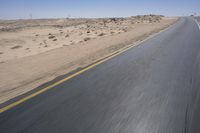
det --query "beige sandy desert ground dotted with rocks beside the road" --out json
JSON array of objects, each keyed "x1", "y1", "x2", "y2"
[{"x1": 0, "y1": 16, "x2": 177, "y2": 103}]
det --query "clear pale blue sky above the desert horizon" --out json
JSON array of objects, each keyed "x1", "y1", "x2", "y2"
[{"x1": 0, "y1": 0, "x2": 200, "y2": 19}]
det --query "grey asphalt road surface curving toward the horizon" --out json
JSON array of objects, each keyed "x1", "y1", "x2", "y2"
[{"x1": 0, "y1": 17, "x2": 200, "y2": 133}]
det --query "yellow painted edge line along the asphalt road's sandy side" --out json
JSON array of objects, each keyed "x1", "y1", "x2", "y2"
[{"x1": 0, "y1": 21, "x2": 174, "y2": 113}]
